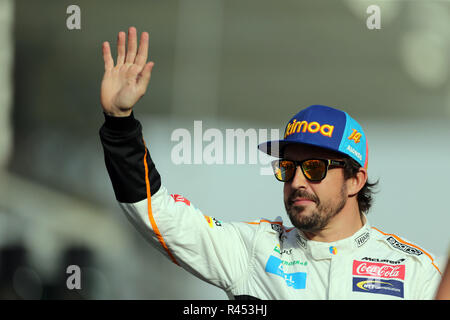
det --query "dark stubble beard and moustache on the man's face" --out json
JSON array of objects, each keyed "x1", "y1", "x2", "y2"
[{"x1": 284, "y1": 184, "x2": 347, "y2": 232}]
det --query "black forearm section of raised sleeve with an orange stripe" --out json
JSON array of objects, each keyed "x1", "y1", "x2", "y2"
[{"x1": 100, "y1": 113, "x2": 161, "y2": 203}]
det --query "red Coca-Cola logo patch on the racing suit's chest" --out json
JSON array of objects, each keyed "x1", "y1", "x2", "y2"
[{"x1": 353, "y1": 260, "x2": 405, "y2": 280}]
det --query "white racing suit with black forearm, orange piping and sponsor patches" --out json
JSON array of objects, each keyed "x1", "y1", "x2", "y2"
[{"x1": 100, "y1": 115, "x2": 441, "y2": 299}]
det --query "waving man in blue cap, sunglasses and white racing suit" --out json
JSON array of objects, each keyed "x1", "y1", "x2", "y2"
[{"x1": 100, "y1": 27, "x2": 440, "y2": 299}]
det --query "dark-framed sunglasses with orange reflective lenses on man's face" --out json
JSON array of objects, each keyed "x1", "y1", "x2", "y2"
[{"x1": 272, "y1": 159, "x2": 345, "y2": 182}]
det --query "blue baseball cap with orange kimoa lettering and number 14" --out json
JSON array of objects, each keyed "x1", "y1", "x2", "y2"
[{"x1": 258, "y1": 105, "x2": 368, "y2": 169}]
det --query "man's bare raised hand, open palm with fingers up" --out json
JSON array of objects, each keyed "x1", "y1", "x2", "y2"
[{"x1": 100, "y1": 27, "x2": 154, "y2": 117}]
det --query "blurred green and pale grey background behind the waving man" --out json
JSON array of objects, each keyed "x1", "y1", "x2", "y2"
[{"x1": 0, "y1": 0, "x2": 450, "y2": 299}]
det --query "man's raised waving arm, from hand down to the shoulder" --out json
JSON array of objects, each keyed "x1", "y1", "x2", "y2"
[{"x1": 100, "y1": 28, "x2": 257, "y2": 291}]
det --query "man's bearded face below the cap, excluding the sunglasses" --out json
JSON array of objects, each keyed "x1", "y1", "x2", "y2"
[{"x1": 284, "y1": 145, "x2": 348, "y2": 232}]
